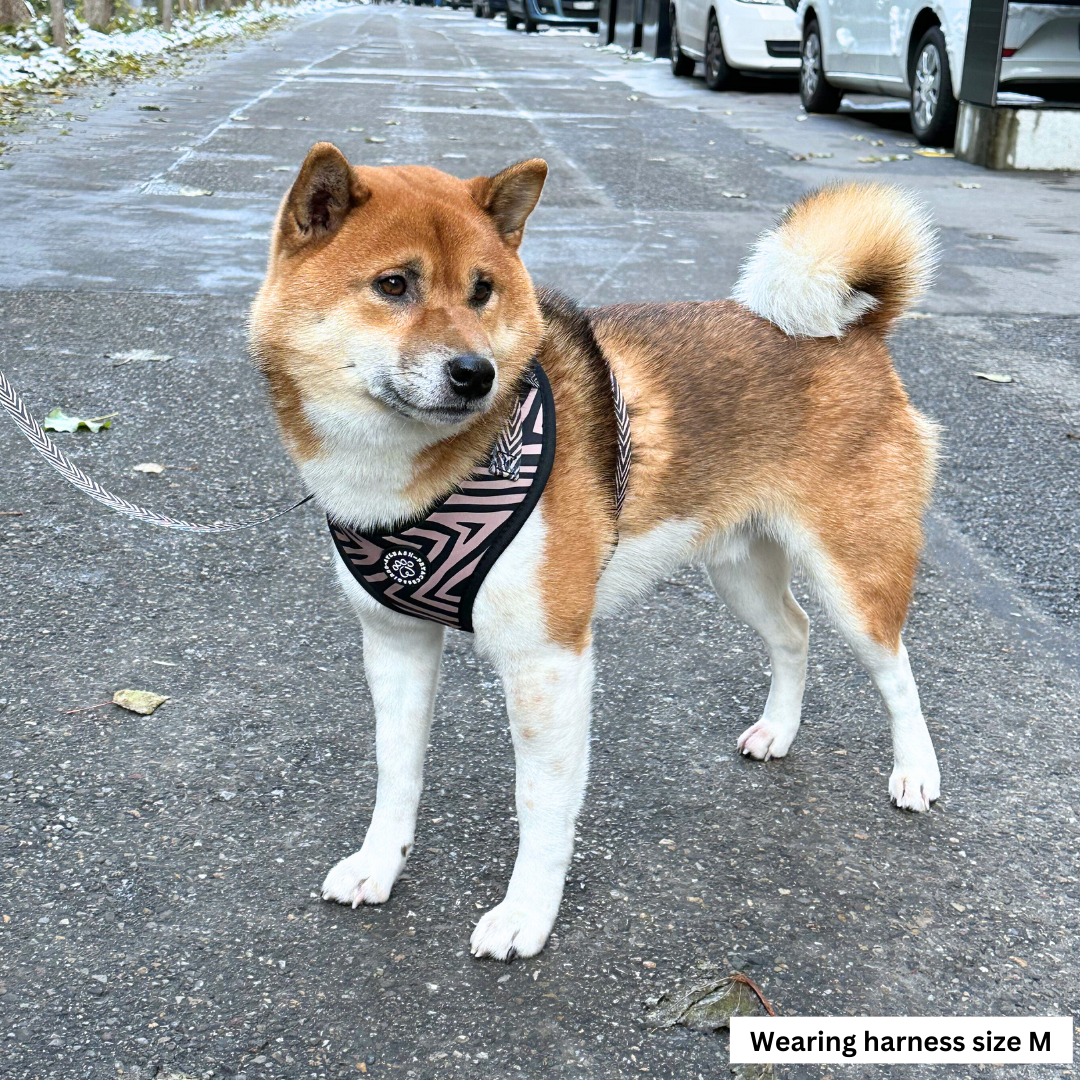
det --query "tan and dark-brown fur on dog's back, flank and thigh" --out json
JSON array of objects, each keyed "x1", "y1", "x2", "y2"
[{"x1": 592, "y1": 301, "x2": 933, "y2": 648}]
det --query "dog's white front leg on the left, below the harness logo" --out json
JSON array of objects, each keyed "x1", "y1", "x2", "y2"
[{"x1": 323, "y1": 580, "x2": 443, "y2": 907}]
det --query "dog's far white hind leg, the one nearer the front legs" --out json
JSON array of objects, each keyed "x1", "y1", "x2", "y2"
[{"x1": 706, "y1": 537, "x2": 809, "y2": 760}]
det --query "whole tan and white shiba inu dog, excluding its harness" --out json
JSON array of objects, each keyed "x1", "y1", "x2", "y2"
[{"x1": 251, "y1": 143, "x2": 939, "y2": 959}]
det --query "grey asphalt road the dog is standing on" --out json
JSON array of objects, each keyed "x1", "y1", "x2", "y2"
[{"x1": 0, "y1": 6, "x2": 1080, "y2": 1080}]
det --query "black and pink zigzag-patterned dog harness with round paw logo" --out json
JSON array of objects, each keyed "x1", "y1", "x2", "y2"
[{"x1": 327, "y1": 362, "x2": 630, "y2": 633}]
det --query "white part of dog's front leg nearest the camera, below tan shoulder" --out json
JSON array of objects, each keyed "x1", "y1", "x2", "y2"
[{"x1": 472, "y1": 646, "x2": 593, "y2": 960}]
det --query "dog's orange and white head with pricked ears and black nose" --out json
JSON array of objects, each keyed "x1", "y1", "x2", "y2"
[{"x1": 252, "y1": 143, "x2": 548, "y2": 458}]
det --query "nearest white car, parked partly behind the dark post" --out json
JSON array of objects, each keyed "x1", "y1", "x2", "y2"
[{"x1": 797, "y1": 0, "x2": 1080, "y2": 146}]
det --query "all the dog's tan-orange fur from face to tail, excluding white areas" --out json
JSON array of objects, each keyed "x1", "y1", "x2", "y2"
[{"x1": 252, "y1": 147, "x2": 933, "y2": 651}]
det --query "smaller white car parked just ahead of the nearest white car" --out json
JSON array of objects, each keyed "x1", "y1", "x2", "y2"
[{"x1": 671, "y1": 0, "x2": 799, "y2": 90}]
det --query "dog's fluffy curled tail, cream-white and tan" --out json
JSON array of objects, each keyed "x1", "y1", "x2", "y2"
[{"x1": 732, "y1": 184, "x2": 937, "y2": 337}]
